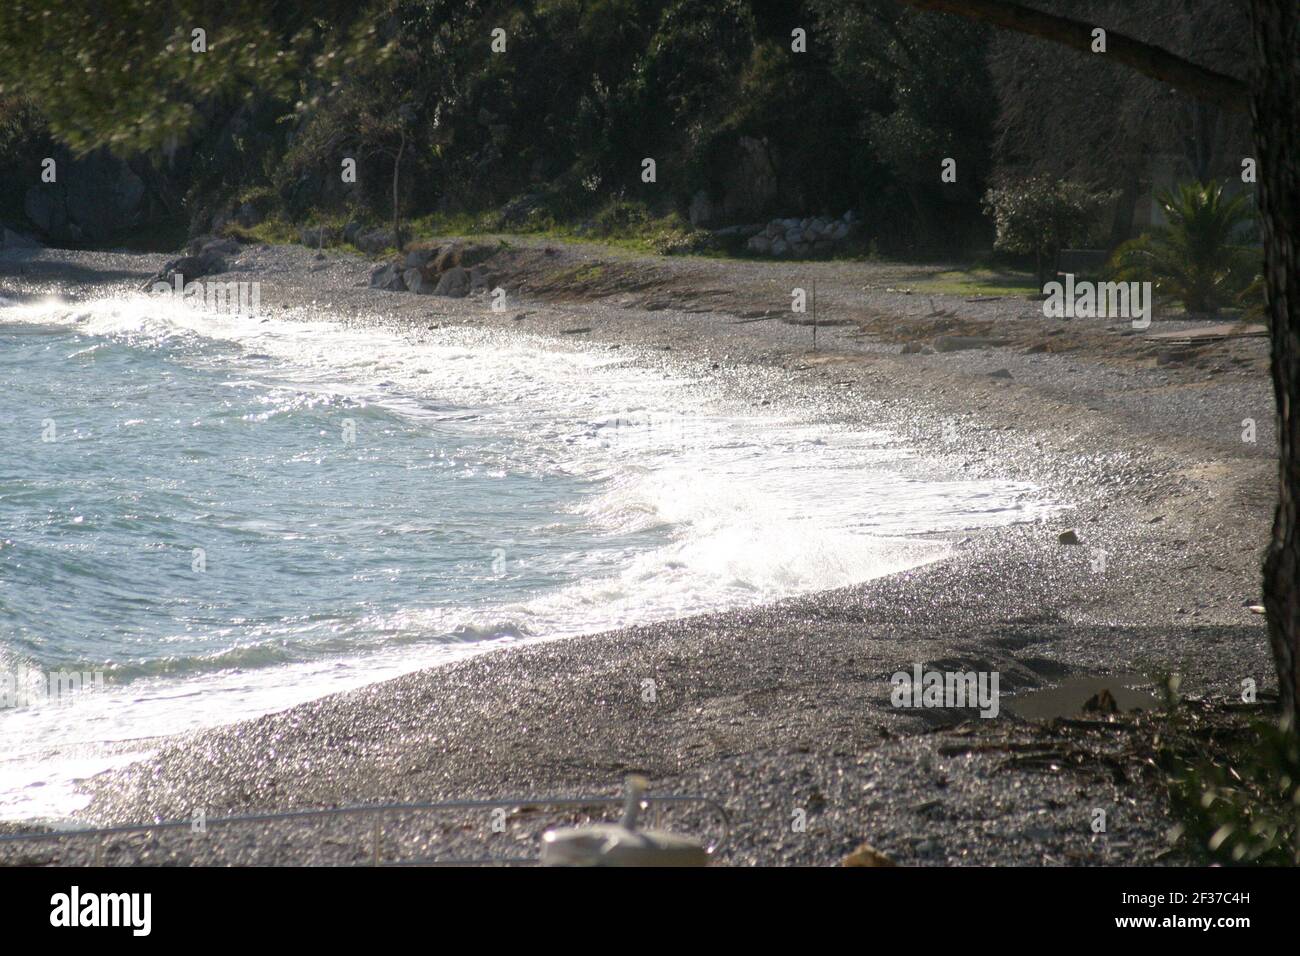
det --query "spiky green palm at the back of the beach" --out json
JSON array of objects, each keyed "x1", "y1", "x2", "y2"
[{"x1": 1110, "y1": 182, "x2": 1261, "y2": 315}]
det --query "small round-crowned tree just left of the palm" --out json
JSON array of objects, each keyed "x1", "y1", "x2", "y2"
[{"x1": 984, "y1": 176, "x2": 1113, "y2": 284}]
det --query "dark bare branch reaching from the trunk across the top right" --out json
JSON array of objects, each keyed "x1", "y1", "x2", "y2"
[{"x1": 902, "y1": 0, "x2": 1251, "y2": 113}]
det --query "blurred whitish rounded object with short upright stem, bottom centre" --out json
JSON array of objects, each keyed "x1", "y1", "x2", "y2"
[{"x1": 542, "y1": 775, "x2": 709, "y2": 866}]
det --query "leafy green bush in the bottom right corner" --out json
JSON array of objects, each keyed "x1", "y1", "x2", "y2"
[{"x1": 1170, "y1": 723, "x2": 1300, "y2": 866}]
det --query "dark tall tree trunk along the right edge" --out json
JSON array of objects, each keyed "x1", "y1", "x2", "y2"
[{"x1": 1251, "y1": 0, "x2": 1300, "y2": 727}]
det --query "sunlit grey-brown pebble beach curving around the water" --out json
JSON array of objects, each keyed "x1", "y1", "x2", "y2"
[{"x1": 0, "y1": 243, "x2": 1275, "y2": 864}]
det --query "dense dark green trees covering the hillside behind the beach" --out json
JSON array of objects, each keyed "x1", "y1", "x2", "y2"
[{"x1": 0, "y1": 0, "x2": 995, "y2": 256}]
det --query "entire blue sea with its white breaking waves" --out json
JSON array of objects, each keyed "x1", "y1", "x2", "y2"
[{"x1": 0, "y1": 297, "x2": 1052, "y2": 818}]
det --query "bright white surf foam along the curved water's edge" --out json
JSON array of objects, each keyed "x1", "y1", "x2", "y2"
[{"x1": 0, "y1": 295, "x2": 1054, "y2": 818}]
